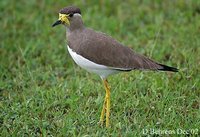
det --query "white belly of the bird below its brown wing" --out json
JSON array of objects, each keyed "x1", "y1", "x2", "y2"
[{"x1": 67, "y1": 46, "x2": 120, "y2": 79}]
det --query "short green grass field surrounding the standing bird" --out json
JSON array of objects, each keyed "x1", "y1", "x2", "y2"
[{"x1": 0, "y1": 0, "x2": 200, "y2": 137}]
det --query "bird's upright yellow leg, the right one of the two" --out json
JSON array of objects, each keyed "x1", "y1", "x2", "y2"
[{"x1": 103, "y1": 80, "x2": 110, "y2": 127}]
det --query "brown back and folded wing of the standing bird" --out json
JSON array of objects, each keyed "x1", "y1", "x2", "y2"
[{"x1": 68, "y1": 28, "x2": 177, "y2": 71}]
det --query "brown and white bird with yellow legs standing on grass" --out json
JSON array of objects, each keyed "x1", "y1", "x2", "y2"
[{"x1": 52, "y1": 6, "x2": 178, "y2": 128}]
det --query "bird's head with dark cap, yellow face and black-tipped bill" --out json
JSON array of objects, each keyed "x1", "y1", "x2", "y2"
[{"x1": 52, "y1": 6, "x2": 81, "y2": 27}]
